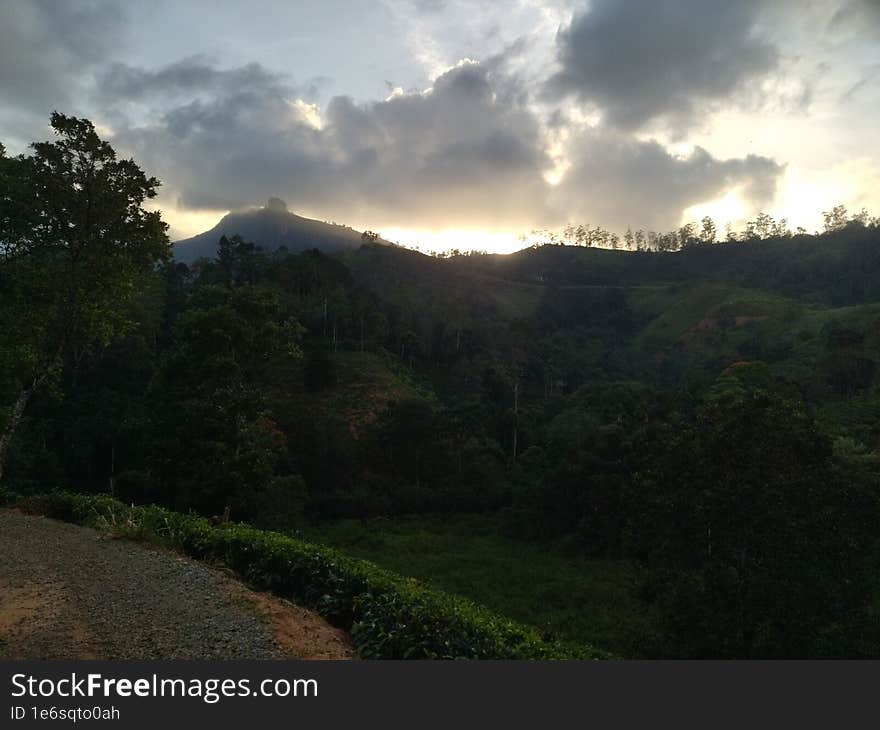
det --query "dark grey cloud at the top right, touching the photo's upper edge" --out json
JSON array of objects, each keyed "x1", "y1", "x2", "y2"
[{"x1": 548, "y1": 0, "x2": 777, "y2": 130}]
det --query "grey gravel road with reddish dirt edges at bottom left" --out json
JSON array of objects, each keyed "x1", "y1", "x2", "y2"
[{"x1": 0, "y1": 510, "x2": 353, "y2": 659}]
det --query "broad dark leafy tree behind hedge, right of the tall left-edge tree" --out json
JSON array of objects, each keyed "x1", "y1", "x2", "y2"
[{"x1": 151, "y1": 284, "x2": 302, "y2": 517}]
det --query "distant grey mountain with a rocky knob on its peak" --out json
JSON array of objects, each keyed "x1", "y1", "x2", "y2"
[{"x1": 173, "y1": 198, "x2": 378, "y2": 263}]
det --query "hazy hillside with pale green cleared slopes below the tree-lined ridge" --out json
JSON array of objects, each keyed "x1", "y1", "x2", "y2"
[{"x1": 341, "y1": 228, "x2": 880, "y2": 396}]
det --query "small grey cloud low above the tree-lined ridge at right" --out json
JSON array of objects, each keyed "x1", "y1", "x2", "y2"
[{"x1": 557, "y1": 130, "x2": 783, "y2": 230}]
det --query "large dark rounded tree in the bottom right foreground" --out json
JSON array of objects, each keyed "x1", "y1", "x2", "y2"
[{"x1": 631, "y1": 364, "x2": 877, "y2": 658}]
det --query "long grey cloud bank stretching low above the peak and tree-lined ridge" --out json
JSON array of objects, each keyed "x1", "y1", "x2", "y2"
[{"x1": 114, "y1": 53, "x2": 783, "y2": 235}]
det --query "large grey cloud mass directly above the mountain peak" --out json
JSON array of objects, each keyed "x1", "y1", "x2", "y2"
[{"x1": 118, "y1": 62, "x2": 551, "y2": 226}]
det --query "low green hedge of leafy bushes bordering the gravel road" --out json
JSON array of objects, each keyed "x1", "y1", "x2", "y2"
[{"x1": 24, "y1": 492, "x2": 610, "y2": 659}]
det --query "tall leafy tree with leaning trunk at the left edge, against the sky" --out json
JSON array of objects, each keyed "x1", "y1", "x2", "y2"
[{"x1": 0, "y1": 112, "x2": 168, "y2": 479}]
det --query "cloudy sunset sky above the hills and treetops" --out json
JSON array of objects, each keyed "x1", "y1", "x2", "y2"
[{"x1": 0, "y1": 0, "x2": 880, "y2": 252}]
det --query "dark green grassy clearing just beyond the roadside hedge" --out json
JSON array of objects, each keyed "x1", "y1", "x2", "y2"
[{"x1": 303, "y1": 515, "x2": 651, "y2": 657}]
